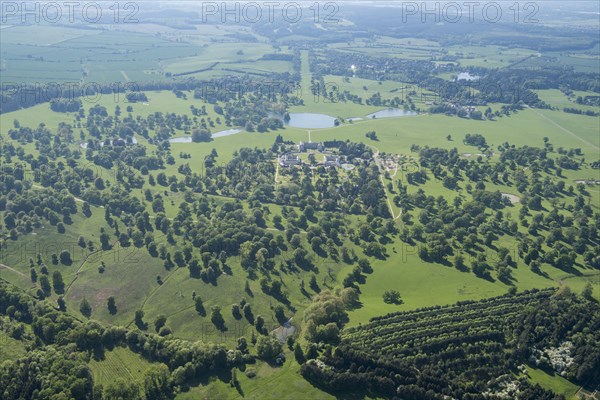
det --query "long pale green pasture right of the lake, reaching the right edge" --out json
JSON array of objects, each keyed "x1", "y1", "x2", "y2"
[{"x1": 311, "y1": 106, "x2": 598, "y2": 159}]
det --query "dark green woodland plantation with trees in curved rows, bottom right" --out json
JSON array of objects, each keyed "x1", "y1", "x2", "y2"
[{"x1": 302, "y1": 290, "x2": 600, "y2": 400}]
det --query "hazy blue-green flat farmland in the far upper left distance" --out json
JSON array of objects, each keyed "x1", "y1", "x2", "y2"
[{"x1": 0, "y1": 24, "x2": 291, "y2": 84}]
